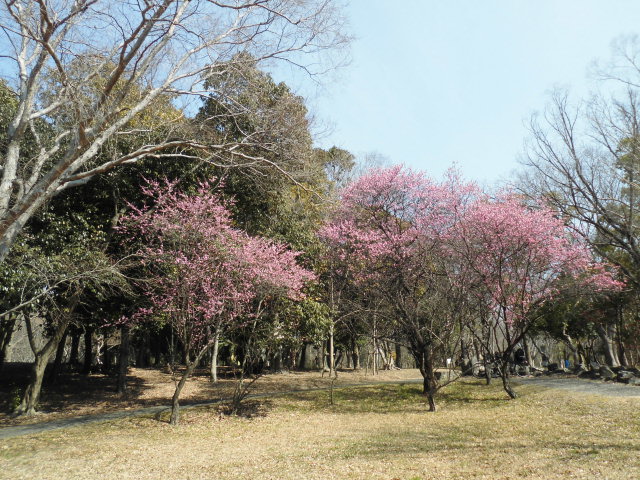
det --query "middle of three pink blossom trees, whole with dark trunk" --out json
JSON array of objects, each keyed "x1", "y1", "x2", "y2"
[{"x1": 320, "y1": 166, "x2": 477, "y2": 411}]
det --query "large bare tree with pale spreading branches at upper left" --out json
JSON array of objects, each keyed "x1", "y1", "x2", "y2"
[{"x1": 0, "y1": 0, "x2": 348, "y2": 261}]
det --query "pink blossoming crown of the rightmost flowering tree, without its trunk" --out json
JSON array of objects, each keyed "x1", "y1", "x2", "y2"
[{"x1": 452, "y1": 193, "x2": 623, "y2": 324}]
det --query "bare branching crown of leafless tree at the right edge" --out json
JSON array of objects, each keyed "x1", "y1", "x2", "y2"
[{"x1": 519, "y1": 38, "x2": 640, "y2": 286}]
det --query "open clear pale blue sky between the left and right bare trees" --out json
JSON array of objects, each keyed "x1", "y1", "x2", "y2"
[{"x1": 296, "y1": 0, "x2": 640, "y2": 184}]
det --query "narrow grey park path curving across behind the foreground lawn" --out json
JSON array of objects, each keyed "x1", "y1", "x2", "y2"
[{"x1": 0, "y1": 377, "x2": 640, "y2": 440}]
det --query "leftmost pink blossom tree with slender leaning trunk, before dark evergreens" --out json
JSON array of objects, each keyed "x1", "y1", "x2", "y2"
[{"x1": 121, "y1": 183, "x2": 313, "y2": 424}]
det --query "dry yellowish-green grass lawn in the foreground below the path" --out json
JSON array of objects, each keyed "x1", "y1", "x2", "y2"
[{"x1": 0, "y1": 380, "x2": 640, "y2": 480}]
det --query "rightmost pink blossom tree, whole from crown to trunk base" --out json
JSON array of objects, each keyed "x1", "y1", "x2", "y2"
[{"x1": 448, "y1": 193, "x2": 623, "y2": 398}]
